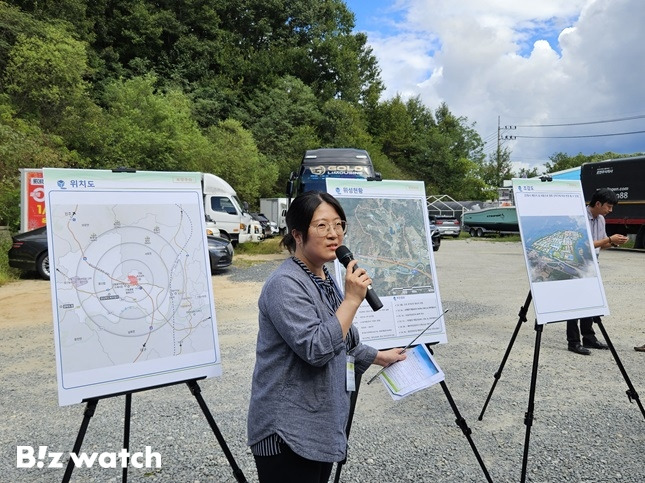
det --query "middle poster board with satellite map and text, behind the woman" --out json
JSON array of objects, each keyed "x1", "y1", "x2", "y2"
[{"x1": 327, "y1": 178, "x2": 447, "y2": 349}]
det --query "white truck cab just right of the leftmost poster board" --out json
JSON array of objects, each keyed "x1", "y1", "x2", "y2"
[{"x1": 202, "y1": 173, "x2": 261, "y2": 244}]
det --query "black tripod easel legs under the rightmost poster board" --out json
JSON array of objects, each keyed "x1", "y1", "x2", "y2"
[{"x1": 479, "y1": 290, "x2": 645, "y2": 483}]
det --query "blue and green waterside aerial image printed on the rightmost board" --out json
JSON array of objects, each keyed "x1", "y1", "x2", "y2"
[{"x1": 521, "y1": 216, "x2": 596, "y2": 282}]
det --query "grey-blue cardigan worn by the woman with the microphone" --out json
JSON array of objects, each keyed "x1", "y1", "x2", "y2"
[{"x1": 247, "y1": 258, "x2": 377, "y2": 462}]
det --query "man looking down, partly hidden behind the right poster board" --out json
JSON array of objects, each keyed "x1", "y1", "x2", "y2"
[{"x1": 567, "y1": 188, "x2": 628, "y2": 355}]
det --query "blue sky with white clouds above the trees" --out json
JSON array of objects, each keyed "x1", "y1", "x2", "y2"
[{"x1": 345, "y1": 0, "x2": 645, "y2": 174}]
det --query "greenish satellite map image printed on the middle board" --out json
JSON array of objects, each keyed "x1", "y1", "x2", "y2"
[{"x1": 341, "y1": 198, "x2": 434, "y2": 296}]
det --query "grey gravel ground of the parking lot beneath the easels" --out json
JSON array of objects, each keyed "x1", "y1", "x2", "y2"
[{"x1": 0, "y1": 240, "x2": 645, "y2": 483}]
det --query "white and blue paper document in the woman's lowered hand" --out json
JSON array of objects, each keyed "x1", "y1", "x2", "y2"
[{"x1": 379, "y1": 344, "x2": 445, "y2": 400}]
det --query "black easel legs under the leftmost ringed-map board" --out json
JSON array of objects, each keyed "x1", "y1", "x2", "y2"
[{"x1": 62, "y1": 378, "x2": 247, "y2": 483}]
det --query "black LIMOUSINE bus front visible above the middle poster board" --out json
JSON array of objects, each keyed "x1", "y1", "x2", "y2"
[{"x1": 287, "y1": 148, "x2": 381, "y2": 199}]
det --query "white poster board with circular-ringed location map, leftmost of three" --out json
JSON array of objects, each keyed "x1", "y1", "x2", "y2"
[{"x1": 44, "y1": 168, "x2": 221, "y2": 406}]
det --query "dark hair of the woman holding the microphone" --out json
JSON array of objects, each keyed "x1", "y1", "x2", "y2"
[{"x1": 280, "y1": 191, "x2": 347, "y2": 253}]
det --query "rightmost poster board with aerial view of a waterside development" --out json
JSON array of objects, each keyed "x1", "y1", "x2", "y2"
[{"x1": 513, "y1": 179, "x2": 609, "y2": 324}]
